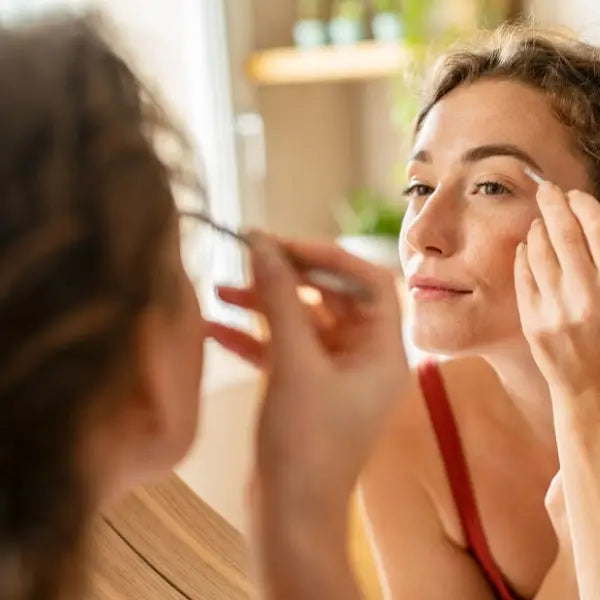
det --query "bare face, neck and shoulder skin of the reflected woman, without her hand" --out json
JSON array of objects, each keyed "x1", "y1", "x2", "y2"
[{"x1": 362, "y1": 79, "x2": 592, "y2": 600}]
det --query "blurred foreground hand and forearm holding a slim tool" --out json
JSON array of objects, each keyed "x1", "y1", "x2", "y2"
[{"x1": 212, "y1": 236, "x2": 408, "y2": 600}]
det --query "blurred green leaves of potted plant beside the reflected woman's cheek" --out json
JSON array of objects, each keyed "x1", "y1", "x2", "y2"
[{"x1": 337, "y1": 187, "x2": 406, "y2": 237}]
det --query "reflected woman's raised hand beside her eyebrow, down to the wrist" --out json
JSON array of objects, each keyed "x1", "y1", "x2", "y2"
[{"x1": 515, "y1": 183, "x2": 600, "y2": 400}]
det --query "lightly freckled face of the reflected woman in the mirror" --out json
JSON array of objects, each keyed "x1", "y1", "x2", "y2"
[{"x1": 400, "y1": 79, "x2": 589, "y2": 355}]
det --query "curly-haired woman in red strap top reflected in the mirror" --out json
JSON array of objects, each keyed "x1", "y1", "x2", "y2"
[{"x1": 217, "y1": 28, "x2": 600, "y2": 600}]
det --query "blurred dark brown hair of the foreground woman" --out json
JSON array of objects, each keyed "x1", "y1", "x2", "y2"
[{"x1": 0, "y1": 17, "x2": 192, "y2": 600}]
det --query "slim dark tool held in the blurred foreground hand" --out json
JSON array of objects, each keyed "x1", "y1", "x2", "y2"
[{"x1": 179, "y1": 210, "x2": 372, "y2": 301}]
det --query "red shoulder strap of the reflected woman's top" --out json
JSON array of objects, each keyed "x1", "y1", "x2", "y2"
[{"x1": 418, "y1": 361, "x2": 518, "y2": 600}]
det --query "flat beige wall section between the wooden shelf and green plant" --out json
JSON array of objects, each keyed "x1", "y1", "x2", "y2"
[{"x1": 260, "y1": 84, "x2": 361, "y2": 235}]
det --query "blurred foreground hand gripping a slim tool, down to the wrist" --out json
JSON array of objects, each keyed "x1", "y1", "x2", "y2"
[{"x1": 212, "y1": 236, "x2": 408, "y2": 508}]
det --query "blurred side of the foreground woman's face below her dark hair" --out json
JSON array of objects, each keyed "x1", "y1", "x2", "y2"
[{"x1": 86, "y1": 220, "x2": 207, "y2": 503}]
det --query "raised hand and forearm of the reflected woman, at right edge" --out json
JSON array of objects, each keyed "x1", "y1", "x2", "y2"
[{"x1": 515, "y1": 183, "x2": 600, "y2": 600}]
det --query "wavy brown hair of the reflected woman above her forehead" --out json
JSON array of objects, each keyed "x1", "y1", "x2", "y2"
[{"x1": 416, "y1": 24, "x2": 600, "y2": 194}]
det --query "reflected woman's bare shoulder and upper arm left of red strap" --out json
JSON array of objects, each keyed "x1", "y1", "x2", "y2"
[{"x1": 361, "y1": 359, "x2": 491, "y2": 600}]
